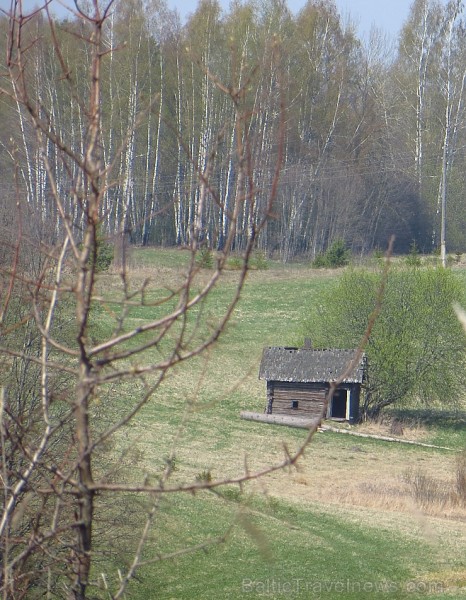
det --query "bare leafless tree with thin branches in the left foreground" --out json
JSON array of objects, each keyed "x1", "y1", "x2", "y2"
[{"x1": 0, "y1": 0, "x2": 342, "y2": 599}]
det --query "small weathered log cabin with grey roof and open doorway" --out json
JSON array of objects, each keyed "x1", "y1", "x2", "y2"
[{"x1": 259, "y1": 347, "x2": 366, "y2": 422}]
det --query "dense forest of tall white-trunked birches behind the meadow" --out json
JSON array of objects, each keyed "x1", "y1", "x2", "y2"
[{"x1": 0, "y1": 0, "x2": 466, "y2": 261}]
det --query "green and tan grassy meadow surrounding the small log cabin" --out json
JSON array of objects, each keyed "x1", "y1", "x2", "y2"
[{"x1": 93, "y1": 249, "x2": 466, "y2": 600}]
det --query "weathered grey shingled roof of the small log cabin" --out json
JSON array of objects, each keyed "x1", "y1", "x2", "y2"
[{"x1": 259, "y1": 347, "x2": 366, "y2": 383}]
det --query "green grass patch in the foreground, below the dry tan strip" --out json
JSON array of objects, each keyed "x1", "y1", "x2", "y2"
[{"x1": 125, "y1": 497, "x2": 446, "y2": 600}]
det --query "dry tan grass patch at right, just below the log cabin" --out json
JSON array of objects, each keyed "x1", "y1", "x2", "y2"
[{"x1": 262, "y1": 433, "x2": 466, "y2": 523}]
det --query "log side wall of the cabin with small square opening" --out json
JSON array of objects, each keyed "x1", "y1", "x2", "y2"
[{"x1": 267, "y1": 381, "x2": 327, "y2": 418}]
